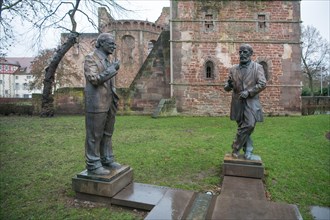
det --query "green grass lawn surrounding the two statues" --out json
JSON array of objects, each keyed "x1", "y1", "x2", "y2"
[{"x1": 0, "y1": 115, "x2": 330, "y2": 219}]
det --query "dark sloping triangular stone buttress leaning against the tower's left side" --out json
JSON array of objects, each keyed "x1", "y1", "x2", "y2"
[{"x1": 117, "y1": 31, "x2": 170, "y2": 114}]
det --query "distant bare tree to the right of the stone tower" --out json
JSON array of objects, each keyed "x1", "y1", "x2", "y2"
[{"x1": 301, "y1": 26, "x2": 330, "y2": 96}]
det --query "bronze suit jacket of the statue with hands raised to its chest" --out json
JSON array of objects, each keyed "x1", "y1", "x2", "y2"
[{"x1": 84, "y1": 50, "x2": 119, "y2": 112}]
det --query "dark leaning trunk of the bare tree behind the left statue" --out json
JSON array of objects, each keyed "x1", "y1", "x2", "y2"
[{"x1": 40, "y1": 33, "x2": 79, "y2": 117}]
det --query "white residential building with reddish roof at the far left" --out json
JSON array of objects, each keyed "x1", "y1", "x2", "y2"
[{"x1": 0, "y1": 57, "x2": 41, "y2": 98}]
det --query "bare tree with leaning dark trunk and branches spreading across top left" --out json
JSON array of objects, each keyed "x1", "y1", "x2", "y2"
[{"x1": 0, "y1": 0, "x2": 127, "y2": 117}]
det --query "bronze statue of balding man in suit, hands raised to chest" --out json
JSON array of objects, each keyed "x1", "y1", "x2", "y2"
[{"x1": 84, "y1": 33, "x2": 121, "y2": 175}]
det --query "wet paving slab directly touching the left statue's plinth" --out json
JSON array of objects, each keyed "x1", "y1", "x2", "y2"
[{"x1": 111, "y1": 183, "x2": 170, "y2": 211}]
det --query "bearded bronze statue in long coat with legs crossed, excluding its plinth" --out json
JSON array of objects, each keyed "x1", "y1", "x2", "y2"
[{"x1": 224, "y1": 44, "x2": 266, "y2": 160}]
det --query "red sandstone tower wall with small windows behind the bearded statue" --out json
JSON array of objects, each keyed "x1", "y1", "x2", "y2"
[{"x1": 172, "y1": 1, "x2": 301, "y2": 115}]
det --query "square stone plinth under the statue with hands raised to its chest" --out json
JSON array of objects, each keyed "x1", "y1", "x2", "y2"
[{"x1": 72, "y1": 168, "x2": 133, "y2": 197}]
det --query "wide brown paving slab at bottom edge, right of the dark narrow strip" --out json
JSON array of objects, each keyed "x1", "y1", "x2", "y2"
[{"x1": 208, "y1": 195, "x2": 302, "y2": 220}]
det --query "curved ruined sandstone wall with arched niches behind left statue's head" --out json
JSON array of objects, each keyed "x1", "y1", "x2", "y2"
[{"x1": 99, "y1": 9, "x2": 164, "y2": 88}]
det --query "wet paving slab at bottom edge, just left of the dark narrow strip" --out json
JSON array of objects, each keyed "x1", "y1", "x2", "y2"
[{"x1": 145, "y1": 189, "x2": 196, "y2": 220}]
